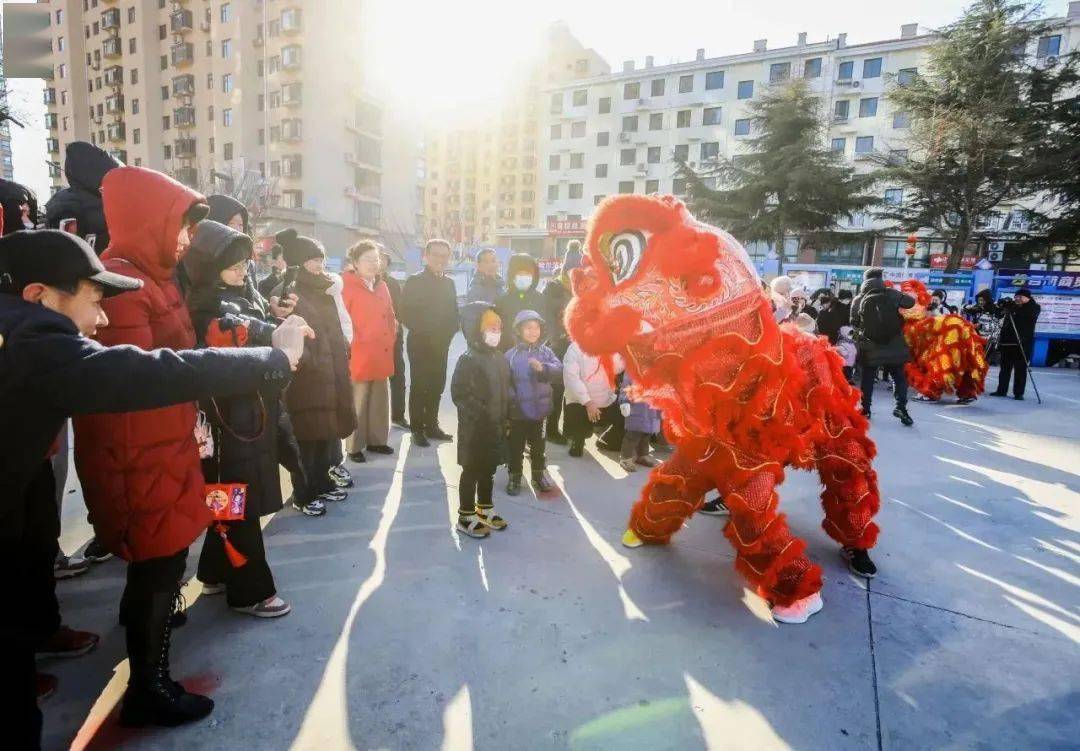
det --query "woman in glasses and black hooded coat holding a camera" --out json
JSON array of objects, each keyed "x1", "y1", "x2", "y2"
[{"x1": 184, "y1": 220, "x2": 289, "y2": 618}]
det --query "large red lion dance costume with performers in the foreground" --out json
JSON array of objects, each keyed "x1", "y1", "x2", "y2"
[{"x1": 566, "y1": 196, "x2": 880, "y2": 622}]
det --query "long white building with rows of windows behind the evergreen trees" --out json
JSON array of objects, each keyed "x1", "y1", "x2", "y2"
[{"x1": 544, "y1": 2, "x2": 1080, "y2": 266}]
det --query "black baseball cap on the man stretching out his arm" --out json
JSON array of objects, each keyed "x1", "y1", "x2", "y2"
[{"x1": 0, "y1": 229, "x2": 143, "y2": 297}]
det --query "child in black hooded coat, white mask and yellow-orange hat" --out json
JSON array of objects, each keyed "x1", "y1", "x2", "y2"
[{"x1": 450, "y1": 303, "x2": 510, "y2": 538}]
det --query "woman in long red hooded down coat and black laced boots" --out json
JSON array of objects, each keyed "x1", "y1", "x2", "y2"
[{"x1": 75, "y1": 166, "x2": 214, "y2": 725}]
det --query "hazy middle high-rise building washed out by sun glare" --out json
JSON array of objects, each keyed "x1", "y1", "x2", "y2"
[{"x1": 423, "y1": 23, "x2": 610, "y2": 257}]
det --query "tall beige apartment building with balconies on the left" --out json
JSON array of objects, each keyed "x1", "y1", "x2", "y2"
[{"x1": 41, "y1": 0, "x2": 383, "y2": 255}]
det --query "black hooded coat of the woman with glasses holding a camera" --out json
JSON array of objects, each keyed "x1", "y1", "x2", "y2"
[{"x1": 184, "y1": 222, "x2": 282, "y2": 520}]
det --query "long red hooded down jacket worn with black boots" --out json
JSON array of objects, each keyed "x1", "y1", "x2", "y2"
[{"x1": 75, "y1": 166, "x2": 211, "y2": 561}]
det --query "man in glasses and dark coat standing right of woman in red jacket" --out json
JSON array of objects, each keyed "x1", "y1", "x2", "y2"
[{"x1": 401, "y1": 240, "x2": 458, "y2": 446}]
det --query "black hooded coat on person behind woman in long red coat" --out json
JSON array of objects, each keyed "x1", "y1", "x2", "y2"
[{"x1": 45, "y1": 140, "x2": 123, "y2": 255}]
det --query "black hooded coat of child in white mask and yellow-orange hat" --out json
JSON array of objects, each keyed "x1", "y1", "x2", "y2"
[{"x1": 450, "y1": 303, "x2": 511, "y2": 470}]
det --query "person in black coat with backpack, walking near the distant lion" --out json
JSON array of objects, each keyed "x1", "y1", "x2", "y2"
[{"x1": 851, "y1": 269, "x2": 915, "y2": 427}]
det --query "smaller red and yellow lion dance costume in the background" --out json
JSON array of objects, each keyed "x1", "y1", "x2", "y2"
[{"x1": 900, "y1": 279, "x2": 989, "y2": 402}]
